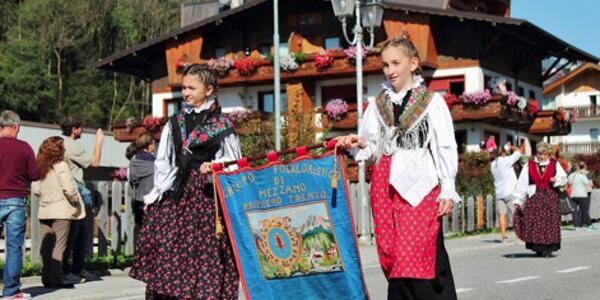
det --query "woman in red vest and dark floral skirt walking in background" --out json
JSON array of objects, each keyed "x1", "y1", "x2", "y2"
[{"x1": 513, "y1": 142, "x2": 568, "y2": 257}]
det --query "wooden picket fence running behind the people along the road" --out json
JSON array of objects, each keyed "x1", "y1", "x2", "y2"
[{"x1": 25, "y1": 181, "x2": 600, "y2": 261}]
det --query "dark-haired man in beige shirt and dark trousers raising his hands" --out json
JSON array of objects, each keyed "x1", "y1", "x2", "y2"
[{"x1": 60, "y1": 116, "x2": 104, "y2": 281}]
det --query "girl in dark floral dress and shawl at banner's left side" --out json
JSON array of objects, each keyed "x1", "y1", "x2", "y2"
[{"x1": 130, "y1": 64, "x2": 241, "y2": 299}]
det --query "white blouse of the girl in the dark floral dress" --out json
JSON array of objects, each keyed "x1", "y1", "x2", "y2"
[{"x1": 144, "y1": 100, "x2": 242, "y2": 204}]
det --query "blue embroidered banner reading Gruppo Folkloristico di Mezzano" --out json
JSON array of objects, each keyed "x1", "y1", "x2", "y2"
[{"x1": 217, "y1": 154, "x2": 368, "y2": 300}]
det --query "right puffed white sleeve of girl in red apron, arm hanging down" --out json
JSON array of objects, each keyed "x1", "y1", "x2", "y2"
[{"x1": 429, "y1": 93, "x2": 462, "y2": 203}]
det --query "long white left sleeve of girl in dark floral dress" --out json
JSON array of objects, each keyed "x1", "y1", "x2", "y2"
[{"x1": 144, "y1": 122, "x2": 178, "y2": 204}]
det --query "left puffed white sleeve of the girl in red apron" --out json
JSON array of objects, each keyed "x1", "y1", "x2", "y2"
[{"x1": 350, "y1": 101, "x2": 381, "y2": 161}]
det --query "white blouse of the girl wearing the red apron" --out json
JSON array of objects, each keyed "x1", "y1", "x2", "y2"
[{"x1": 351, "y1": 76, "x2": 462, "y2": 207}]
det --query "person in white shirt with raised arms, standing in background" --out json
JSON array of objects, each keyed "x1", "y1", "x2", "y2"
[{"x1": 490, "y1": 143, "x2": 524, "y2": 243}]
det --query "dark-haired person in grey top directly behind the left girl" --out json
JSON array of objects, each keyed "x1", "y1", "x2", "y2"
[{"x1": 125, "y1": 133, "x2": 156, "y2": 243}]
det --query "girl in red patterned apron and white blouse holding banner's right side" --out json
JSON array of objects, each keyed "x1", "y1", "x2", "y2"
[{"x1": 337, "y1": 37, "x2": 461, "y2": 300}]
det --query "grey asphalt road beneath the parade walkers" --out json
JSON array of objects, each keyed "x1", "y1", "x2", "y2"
[{"x1": 15, "y1": 224, "x2": 600, "y2": 300}]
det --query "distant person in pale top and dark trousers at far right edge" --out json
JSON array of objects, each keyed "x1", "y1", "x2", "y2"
[{"x1": 569, "y1": 161, "x2": 596, "y2": 231}]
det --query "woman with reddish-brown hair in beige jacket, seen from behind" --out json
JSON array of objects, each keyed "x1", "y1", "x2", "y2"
[{"x1": 32, "y1": 136, "x2": 85, "y2": 288}]
